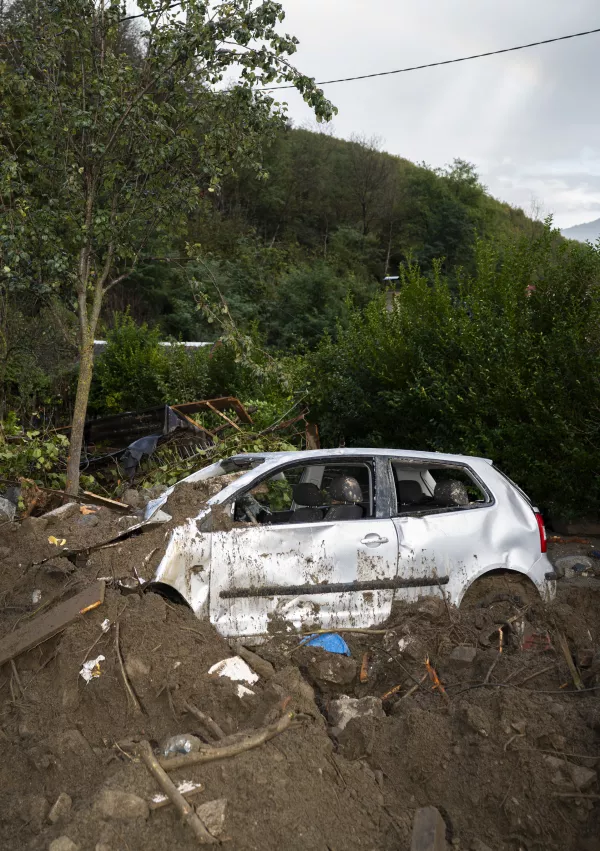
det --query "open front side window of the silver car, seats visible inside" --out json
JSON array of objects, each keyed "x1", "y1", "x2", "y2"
[{"x1": 235, "y1": 461, "x2": 373, "y2": 524}]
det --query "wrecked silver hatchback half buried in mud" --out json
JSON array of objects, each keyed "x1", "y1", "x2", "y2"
[{"x1": 145, "y1": 449, "x2": 555, "y2": 638}]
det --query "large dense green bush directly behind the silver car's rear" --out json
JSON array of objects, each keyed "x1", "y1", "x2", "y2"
[{"x1": 306, "y1": 225, "x2": 600, "y2": 516}]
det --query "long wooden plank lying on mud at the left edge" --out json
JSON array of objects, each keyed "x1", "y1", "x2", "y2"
[{"x1": 0, "y1": 580, "x2": 104, "y2": 665}]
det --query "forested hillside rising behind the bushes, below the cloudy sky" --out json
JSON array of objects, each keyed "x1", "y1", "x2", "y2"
[{"x1": 104, "y1": 129, "x2": 541, "y2": 349}]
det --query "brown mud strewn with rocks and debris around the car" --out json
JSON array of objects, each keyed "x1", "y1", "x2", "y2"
[{"x1": 0, "y1": 500, "x2": 600, "y2": 851}]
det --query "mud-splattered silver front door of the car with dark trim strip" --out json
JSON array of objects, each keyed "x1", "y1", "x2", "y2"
[{"x1": 210, "y1": 455, "x2": 398, "y2": 636}]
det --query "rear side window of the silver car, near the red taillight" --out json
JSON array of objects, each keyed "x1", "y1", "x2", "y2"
[{"x1": 392, "y1": 460, "x2": 491, "y2": 514}]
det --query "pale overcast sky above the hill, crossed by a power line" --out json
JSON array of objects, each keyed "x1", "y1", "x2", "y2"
[{"x1": 274, "y1": 0, "x2": 600, "y2": 227}]
